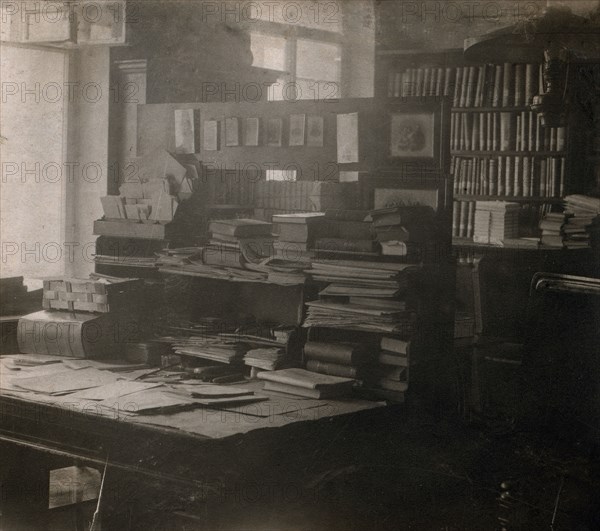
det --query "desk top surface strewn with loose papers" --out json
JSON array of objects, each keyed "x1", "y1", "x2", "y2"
[{"x1": 0, "y1": 355, "x2": 384, "y2": 440}]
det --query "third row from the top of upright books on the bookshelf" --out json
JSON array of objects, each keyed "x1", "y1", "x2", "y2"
[{"x1": 451, "y1": 155, "x2": 566, "y2": 198}]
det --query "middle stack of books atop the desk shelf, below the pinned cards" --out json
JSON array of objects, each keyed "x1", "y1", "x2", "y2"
[{"x1": 272, "y1": 212, "x2": 325, "y2": 261}]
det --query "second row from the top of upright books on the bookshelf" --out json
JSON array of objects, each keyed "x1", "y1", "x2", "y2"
[{"x1": 450, "y1": 111, "x2": 566, "y2": 152}]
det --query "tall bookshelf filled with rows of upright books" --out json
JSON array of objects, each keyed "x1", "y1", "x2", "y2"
[{"x1": 376, "y1": 49, "x2": 591, "y2": 243}]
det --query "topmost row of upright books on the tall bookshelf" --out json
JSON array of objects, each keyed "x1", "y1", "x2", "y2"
[{"x1": 388, "y1": 63, "x2": 544, "y2": 107}]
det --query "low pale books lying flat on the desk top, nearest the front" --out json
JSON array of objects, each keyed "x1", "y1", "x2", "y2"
[{"x1": 258, "y1": 369, "x2": 354, "y2": 399}]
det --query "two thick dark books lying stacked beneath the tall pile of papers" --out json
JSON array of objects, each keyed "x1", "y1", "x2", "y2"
[{"x1": 304, "y1": 341, "x2": 373, "y2": 379}]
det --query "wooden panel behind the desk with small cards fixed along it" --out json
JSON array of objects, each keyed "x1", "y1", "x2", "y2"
[{"x1": 137, "y1": 98, "x2": 385, "y2": 181}]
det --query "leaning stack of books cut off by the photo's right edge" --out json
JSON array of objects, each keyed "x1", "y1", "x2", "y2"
[{"x1": 563, "y1": 194, "x2": 600, "y2": 249}]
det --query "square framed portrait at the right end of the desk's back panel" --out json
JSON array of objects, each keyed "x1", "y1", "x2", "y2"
[{"x1": 386, "y1": 98, "x2": 450, "y2": 175}]
